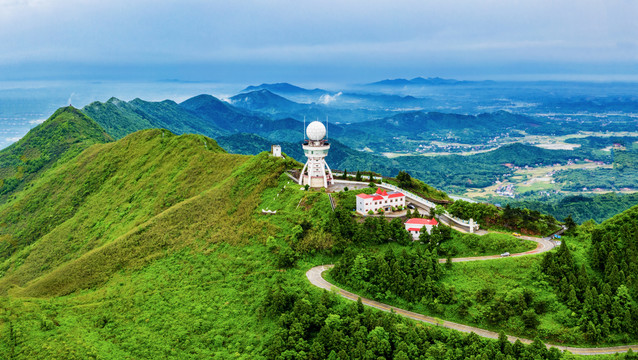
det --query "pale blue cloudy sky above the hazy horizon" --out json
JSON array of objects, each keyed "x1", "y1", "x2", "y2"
[{"x1": 0, "y1": 0, "x2": 638, "y2": 83}]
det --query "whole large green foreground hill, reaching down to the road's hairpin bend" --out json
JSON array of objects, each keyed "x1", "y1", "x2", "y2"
[{"x1": 0, "y1": 119, "x2": 632, "y2": 359}]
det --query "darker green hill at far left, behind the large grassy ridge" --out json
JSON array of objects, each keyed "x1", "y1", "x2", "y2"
[{"x1": 0, "y1": 106, "x2": 113, "y2": 201}]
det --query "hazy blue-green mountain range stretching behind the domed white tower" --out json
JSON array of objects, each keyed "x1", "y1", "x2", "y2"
[{"x1": 83, "y1": 89, "x2": 560, "y2": 152}]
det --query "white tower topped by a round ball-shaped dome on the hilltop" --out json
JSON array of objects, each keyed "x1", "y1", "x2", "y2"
[{"x1": 299, "y1": 121, "x2": 332, "y2": 188}]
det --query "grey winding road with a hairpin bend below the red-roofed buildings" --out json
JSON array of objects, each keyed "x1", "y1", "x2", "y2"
[{"x1": 306, "y1": 236, "x2": 638, "y2": 355}]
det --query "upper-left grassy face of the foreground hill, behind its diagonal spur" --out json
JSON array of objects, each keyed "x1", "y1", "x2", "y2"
[{"x1": 0, "y1": 130, "x2": 247, "y2": 291}]
